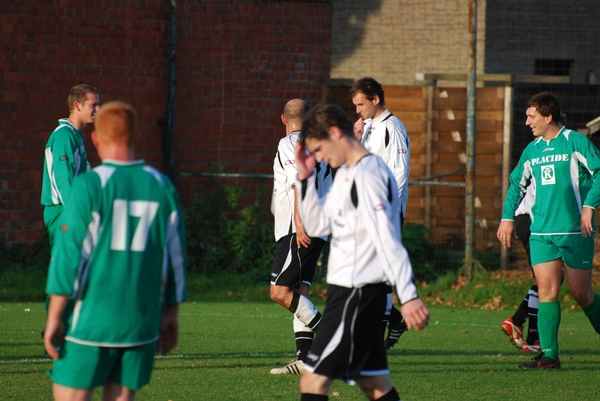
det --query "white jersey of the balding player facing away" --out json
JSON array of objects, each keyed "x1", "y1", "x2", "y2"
[{"x1": 271, "y1": 131, "x2": 331, "y2": 241}]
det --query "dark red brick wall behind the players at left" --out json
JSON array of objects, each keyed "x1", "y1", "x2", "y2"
[{"x1": 0, "y1": 0, "x2": 331, "y2": 243}]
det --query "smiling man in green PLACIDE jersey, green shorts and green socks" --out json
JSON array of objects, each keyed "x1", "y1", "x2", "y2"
[{"x1": 497, "y1": 92, "x2": 600, "y2": 369}]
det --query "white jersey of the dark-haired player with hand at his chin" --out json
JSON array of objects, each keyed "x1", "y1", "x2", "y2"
[{"x1": 361, "y1": 109, "x2": 410, "y2": 216}]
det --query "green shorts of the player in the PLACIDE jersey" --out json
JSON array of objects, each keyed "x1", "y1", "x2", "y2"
[{"x1": 529, "y1": 234, "x2": 594, "y2": 270}]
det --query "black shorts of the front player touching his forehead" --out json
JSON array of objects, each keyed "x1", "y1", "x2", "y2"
[{"x1": 304, "y1": 284, "x2": 390, "y2": 382}]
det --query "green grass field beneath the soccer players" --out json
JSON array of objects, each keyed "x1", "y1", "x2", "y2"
[{"x1": 0, "y1": 302, "x2": 600, "y2": 401}]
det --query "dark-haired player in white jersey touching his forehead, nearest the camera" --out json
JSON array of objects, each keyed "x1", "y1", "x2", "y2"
[{"x1": 296, "y1": 104, "x2": 429, "y2": 401}]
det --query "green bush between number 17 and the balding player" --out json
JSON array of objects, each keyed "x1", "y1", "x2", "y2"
[{"x1": 185, "y1": 167, "x2": 276, "y2": 283}]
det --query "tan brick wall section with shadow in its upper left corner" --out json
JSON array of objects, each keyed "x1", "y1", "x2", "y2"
[{"x1": 331, "y1": 0, "x2": 486, "y2": 85}]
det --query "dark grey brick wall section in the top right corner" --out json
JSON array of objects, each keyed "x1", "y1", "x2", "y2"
[{"x1": 485, "y1": 0, "x2": 600, "y2": 84}]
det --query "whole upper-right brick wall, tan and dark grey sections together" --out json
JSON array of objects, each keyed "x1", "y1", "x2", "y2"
[{"x1": 331, "y1": 0, "x2": 600, "y2": 85}]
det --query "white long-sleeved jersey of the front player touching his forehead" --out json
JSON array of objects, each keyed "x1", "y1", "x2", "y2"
[{"x1": 299, "y1": 155, "x2": 417, "y2": 303}]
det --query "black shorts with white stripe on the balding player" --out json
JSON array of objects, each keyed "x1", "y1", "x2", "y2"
[{"x1": 271, "y1": 233, "x2": 325, "y2": 288}]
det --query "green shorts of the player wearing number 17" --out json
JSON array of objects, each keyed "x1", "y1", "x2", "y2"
[{"x1": 52, "y1": 341, "x2": 156, "y2": 391}]
